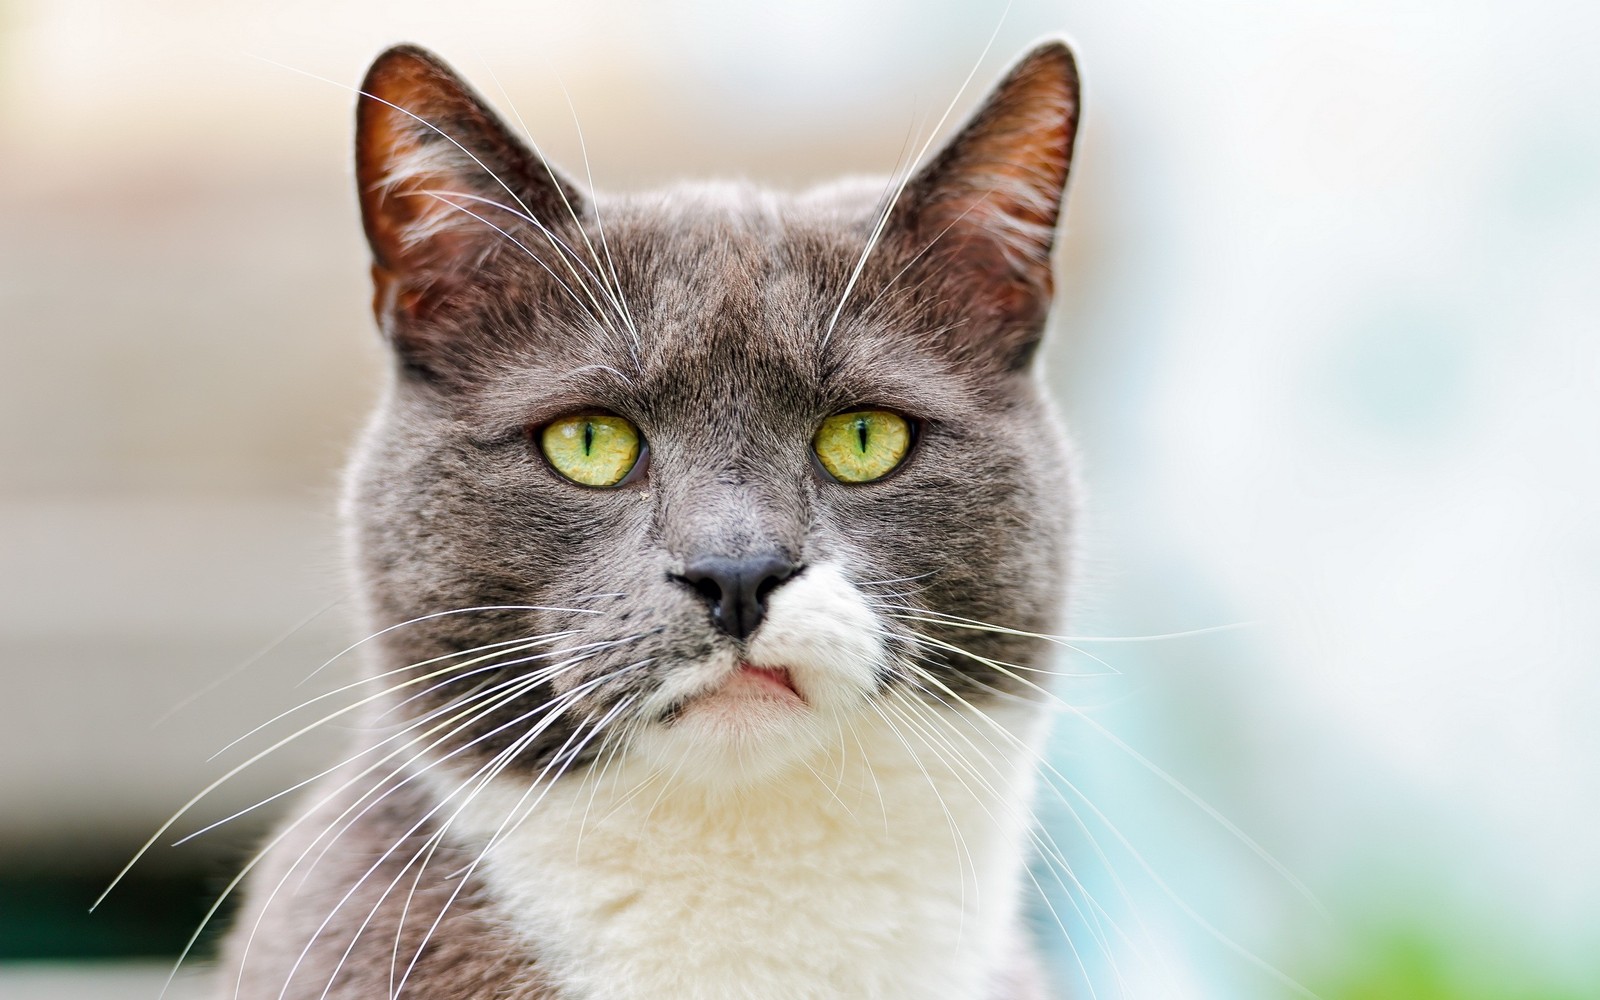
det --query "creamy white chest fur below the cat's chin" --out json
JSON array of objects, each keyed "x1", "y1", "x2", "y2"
[{"x1": 435, "y1": 707, "x2": 1035, "y2": 1000}]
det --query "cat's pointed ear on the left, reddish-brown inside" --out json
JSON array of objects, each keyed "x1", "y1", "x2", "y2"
[{"x1": 355, "y1": 45, "x2": 586, "y2": 331}]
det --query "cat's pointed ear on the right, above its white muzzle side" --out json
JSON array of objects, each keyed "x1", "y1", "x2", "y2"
[{"x1": 893, "y1": 40, "x2": 1078, "y2": 370}]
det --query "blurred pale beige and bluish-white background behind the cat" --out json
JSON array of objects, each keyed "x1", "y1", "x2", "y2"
[{"x1": 0, "y1": 0, "x2": 1600, "y2": 1000}]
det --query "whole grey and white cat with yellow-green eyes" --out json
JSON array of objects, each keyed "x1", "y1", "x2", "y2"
[{"x1": 219, "y1": 42, "x2": 1078, "y2": 1000}]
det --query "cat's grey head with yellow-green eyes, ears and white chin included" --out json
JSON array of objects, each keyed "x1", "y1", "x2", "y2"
[{"x1": 349, "y1": 42, "x2": 1078, "y2": 781}]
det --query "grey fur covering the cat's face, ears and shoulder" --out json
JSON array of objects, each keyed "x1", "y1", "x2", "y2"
[{"x1": 212, "y1": 43, "x2": 1077, "y2": 1000}]
